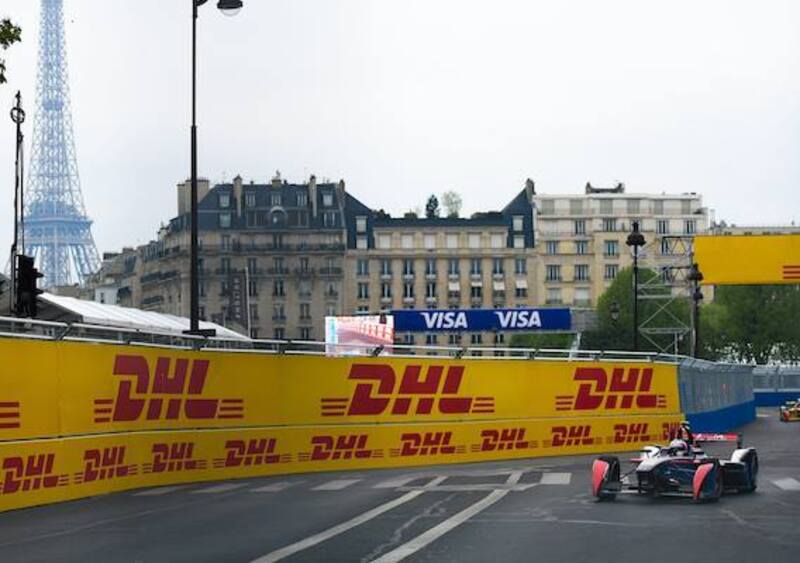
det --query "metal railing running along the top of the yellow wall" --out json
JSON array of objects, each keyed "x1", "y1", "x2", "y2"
[{"x1": 0, "y1": 317, "x2": 686, "y2": 364}]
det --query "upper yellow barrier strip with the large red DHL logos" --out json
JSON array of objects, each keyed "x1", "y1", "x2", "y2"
[{"x1": 0, "y1": 339, "x2": 680, "y2": 440}]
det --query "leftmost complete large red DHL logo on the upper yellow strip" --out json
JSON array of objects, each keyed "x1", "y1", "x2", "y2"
[{"x1": 94, "y1": 355, "x2": 244, "y2": 423}]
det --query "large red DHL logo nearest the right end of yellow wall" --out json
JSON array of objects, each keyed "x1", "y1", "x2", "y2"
[{"x1": 556, "y1": 367, "x2": 667, "y2": 411}]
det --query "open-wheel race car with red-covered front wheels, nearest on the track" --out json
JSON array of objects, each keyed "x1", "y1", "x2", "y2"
[{"x1": 592, "y1": 434, "x2": 758, "y2": 502}]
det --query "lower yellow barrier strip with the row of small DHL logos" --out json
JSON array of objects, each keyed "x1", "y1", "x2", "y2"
[{"x1": 0, "y1": 415, "x2": 680, "y2": 511}]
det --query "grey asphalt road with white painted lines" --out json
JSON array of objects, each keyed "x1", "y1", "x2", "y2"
[{"x1": 0, "y1": 409, "x2": 800, "y2": 563}]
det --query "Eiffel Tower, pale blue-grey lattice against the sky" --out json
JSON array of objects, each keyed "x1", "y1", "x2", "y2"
[{"x1": 25, "y1": 0, "x2": 100, "y2": 287}]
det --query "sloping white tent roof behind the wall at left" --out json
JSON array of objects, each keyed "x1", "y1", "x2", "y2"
[{"x1": 39, "y1": 293, "x2": 249, "y2": 340}]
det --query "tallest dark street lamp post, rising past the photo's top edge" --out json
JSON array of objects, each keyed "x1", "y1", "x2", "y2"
[{"x1": 187, "y1": 0, "x2": 242, "y2": 336}]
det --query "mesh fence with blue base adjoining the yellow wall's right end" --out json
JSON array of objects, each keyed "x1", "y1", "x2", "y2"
[{"x1": 678, "y1": 359, "x2": 756, "y2": 432}]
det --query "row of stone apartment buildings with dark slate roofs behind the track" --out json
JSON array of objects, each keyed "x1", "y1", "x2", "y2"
[{"x1": 87, "y1": 176, "x2": 708, "y2": 345}]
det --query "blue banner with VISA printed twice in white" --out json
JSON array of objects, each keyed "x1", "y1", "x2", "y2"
[{"x1": 392, "y1": 308, "x2": 572, "y2": 332}]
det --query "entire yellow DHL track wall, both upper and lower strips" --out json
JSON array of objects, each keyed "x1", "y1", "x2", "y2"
[{"x1": 0, "y1": 339, "x2": 683, "y2": 510}]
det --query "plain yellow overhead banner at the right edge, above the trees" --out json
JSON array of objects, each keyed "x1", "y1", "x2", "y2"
[{"x1": 694, "y1": 234, "x2": 800, "y2": 285}]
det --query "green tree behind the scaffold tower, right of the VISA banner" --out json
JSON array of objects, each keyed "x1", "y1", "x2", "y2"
[{"x1": 581, "y1": 268, "x2": 691, "y2": 354}]
